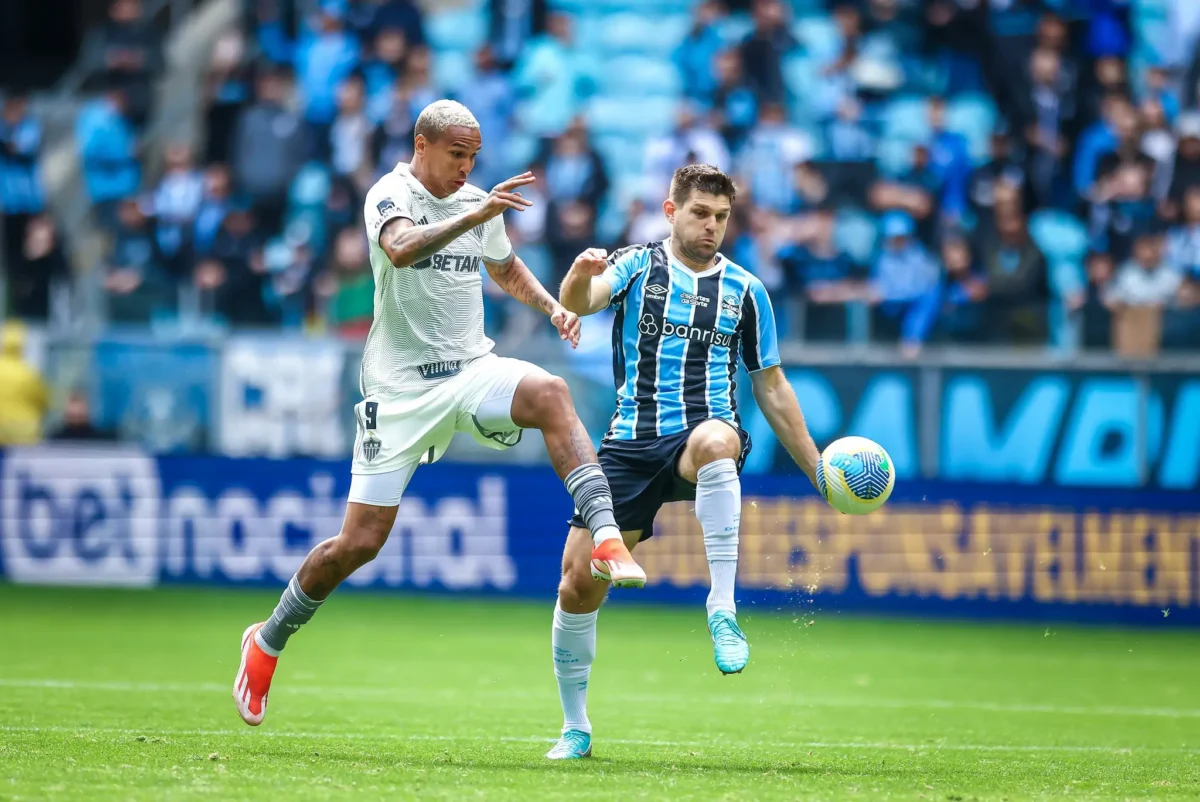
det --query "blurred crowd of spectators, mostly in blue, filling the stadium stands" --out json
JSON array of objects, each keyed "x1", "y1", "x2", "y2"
[{"x1": 7, "y1": 0, "x2": 1200, "y2": 353}]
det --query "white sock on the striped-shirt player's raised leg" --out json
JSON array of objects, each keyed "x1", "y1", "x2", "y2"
[{"x1": 696, "y1": 459, "x2": 742, "y2": 615}]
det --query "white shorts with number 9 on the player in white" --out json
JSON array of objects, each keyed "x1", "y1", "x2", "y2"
[{"x1": 349, "y1": 354, "x2": 542, "y2": 507}]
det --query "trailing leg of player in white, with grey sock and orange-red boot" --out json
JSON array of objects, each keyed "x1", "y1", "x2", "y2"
[{"x1": 233, "y1": 482, "x2": 413, "y2": 726}]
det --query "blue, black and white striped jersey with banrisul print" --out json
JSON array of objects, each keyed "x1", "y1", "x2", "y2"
[{"x1": 602, "y1": 241, "x2": 779, "y2": 439}]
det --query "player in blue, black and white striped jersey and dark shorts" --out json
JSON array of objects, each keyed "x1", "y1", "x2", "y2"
[{"x1": 546, "y1": 164, "x2": 821, "y2": 760}]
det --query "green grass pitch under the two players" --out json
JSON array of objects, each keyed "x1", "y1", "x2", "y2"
[{"x1": 0, "y1": 586, "x2": 1200, "y2": 802}]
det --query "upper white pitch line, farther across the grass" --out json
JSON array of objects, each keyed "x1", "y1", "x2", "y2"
[{"x1": 0, "y1": 678, "x2": 1200, "y2": 718}]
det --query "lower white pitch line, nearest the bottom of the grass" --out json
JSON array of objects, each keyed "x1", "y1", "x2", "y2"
[{"x1": 0, "y1": 725, "x2": 1200, "y2": 755}]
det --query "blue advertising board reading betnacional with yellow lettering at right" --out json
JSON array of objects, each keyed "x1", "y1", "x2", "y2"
[{"x1": 0, "y1": 447, "x2": 1200, "y2": 627}]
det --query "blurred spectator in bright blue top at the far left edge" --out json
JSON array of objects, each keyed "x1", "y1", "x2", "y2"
[{"x1": 0, "y1": 92, "x2": 46, "y2": 286}]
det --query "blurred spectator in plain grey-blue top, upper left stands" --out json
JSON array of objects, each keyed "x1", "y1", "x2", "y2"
[{"x1": 233, "y1": 71, "x2": 308, "y2": 232}]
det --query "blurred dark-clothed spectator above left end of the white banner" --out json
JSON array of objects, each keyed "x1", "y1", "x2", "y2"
[{"x1": 192, "y1": 201, "x2": 271, "y2": 325}]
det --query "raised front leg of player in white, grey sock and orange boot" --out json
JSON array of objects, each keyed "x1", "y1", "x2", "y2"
[{"x1": 512, "y1": 371, "x2": 646, "y2": 587}]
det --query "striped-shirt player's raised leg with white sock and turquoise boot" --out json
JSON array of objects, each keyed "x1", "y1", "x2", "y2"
[{"x1": 679, "y1": 420, "x2": 750, "y2": 674}]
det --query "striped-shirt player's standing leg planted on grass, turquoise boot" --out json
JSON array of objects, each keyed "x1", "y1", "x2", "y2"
[{"x1": 546, "y1": 526, "x2": 642, "y2": 760}]
